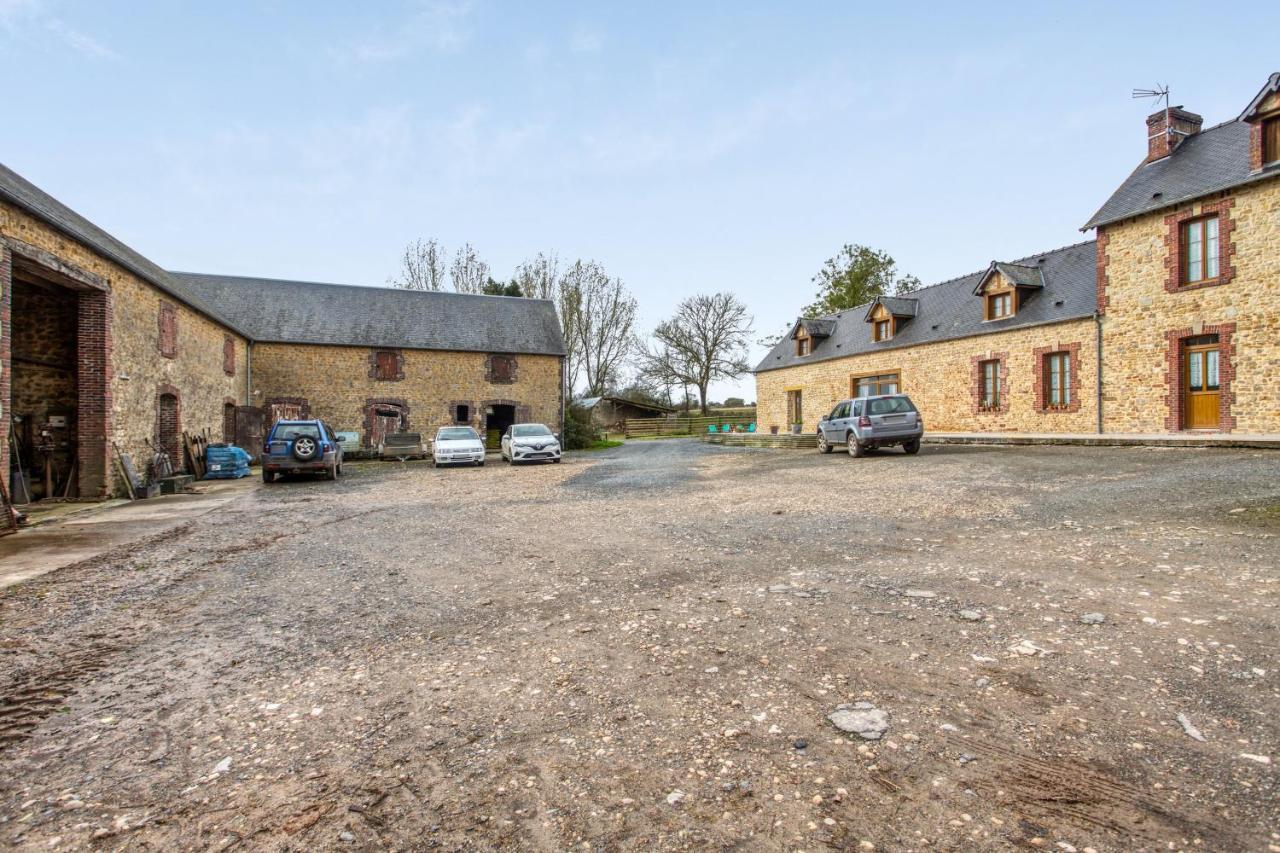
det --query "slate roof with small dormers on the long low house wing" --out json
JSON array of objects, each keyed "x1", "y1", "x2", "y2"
[{"x1": 755, "y1": 240, "x2": 1097, "y2": 373}]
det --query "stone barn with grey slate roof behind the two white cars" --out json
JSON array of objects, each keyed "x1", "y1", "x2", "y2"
[{"x1": 173, "y1": 273, "x2": 564, "y2": 447}]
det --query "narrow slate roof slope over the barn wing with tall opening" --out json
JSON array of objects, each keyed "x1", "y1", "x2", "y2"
[{"x1": 0, "y1": 164, "x2": 244, "y2": 334}]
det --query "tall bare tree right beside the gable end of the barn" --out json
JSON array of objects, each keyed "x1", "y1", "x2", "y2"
[{"x1": 559, "y1": 260, "x2": 636, "y2": 396}]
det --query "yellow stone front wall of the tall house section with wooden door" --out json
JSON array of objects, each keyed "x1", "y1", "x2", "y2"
[{"x1": 1098, "y1": 179, "x2": 1280, "y2": 433}]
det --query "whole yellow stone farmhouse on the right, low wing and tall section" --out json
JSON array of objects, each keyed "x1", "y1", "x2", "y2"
[{"x1": 755, "y1": 73, "x2": 1280, "y2": 434}]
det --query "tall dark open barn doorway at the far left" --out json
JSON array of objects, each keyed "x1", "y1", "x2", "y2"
[{"x1": 8, "y1": 275, "x2": 81, "y2": 503}]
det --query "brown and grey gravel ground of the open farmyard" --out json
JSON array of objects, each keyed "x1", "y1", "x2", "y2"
[{"x1": 0, "y1": 441, "x2": 1280, "y2": 850}]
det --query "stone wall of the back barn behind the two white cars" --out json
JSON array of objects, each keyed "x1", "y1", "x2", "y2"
[{"x1": 252, "y1": 343, "x2": 561, "y2": 435}]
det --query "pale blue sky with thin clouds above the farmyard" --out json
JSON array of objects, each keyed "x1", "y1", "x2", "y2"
[{"x1": 0, "y1": 0, "x2": 1280, "y2": 400}]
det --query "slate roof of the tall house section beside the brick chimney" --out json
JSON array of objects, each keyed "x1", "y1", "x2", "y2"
[{"x1": 1080, "y1": 119, "x2": 1280, "y2": 231}]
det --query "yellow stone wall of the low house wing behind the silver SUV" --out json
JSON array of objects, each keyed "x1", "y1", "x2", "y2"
[{"x1": 755, "y1": 315, "x2": 1097, "y2": 433}]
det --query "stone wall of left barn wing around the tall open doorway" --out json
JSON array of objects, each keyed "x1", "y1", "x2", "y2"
[{"x1": 0, "y1": 202, "x2": 246, "y2": 497}]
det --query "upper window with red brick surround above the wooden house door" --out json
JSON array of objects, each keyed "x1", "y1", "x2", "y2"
[{"x1": 1165, "y1": 199, "x2": 1235, "y2": 293}]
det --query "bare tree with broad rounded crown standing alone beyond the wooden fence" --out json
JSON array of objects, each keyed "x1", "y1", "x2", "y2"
[{"x1": 640, "y1": 293, "x2": 751, "y2": 415}]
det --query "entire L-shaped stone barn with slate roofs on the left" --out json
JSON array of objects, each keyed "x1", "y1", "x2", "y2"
[{"x1": 0, "y1": 165, "x2": 564, "y2": 498}]
